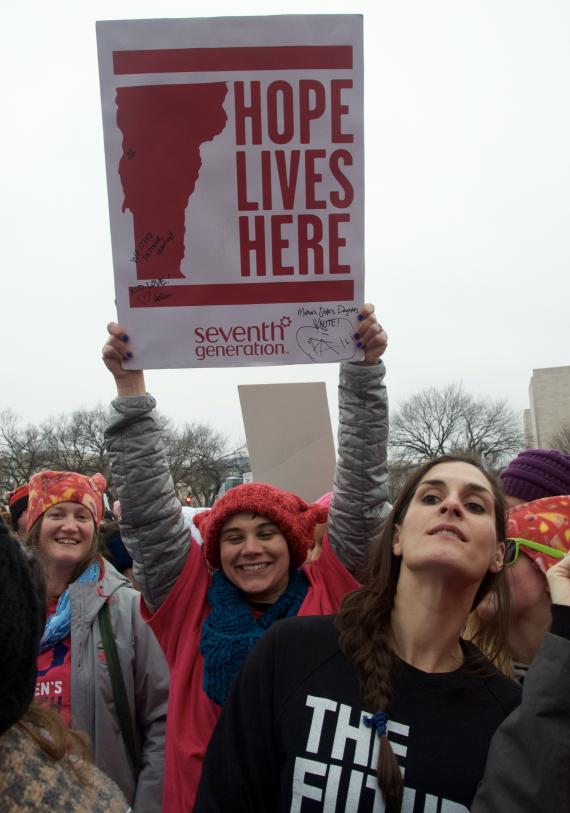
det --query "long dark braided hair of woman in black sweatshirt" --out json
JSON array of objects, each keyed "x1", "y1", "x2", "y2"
[{"x1": 336, "y1": 454, "x2": 508, "y2": 811}]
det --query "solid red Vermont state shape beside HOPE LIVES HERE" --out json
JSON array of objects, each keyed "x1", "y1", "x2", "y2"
[{"x1": 117, "y1": 82, "x2": 228, "y2": 280}]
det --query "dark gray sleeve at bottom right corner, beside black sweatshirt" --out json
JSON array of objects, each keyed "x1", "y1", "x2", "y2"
[{"x1": 471, "y1": 634, "x2": 570, "y2": 813}]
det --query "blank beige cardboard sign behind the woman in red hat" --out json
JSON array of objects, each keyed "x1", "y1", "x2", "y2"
[{"x1": 238, "y1": 381, "x2": 335, "y2": 502}]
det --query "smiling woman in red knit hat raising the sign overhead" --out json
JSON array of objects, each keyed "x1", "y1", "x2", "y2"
[{"x1": 103, "y1": 306, "x2": 387, "y2": 813}]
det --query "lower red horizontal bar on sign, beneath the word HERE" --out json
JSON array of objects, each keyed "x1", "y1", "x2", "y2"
[{"x1": 129, "y1": 280, "x2": 354, "y2": 308}]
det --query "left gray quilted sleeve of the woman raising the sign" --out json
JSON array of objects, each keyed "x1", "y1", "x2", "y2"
[{"x1": 105, "y1": 395, "x2": 191, "y2": 613}]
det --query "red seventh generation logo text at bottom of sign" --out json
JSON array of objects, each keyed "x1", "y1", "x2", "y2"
[{"x1": 194, "y1": 316, "x2": 291, "y2": 361}]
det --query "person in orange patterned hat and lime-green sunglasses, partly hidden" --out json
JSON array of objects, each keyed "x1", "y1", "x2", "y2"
[{"x1": 468, "y1": 496, "x2": 570, "y2": 683}]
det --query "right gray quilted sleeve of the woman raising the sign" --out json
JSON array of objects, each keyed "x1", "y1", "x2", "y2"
[{"x1": 328, "y1": 361, "x2": 391, "y2": 578}]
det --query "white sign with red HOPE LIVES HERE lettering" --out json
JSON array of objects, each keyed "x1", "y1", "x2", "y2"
[{"x1": 97, "y1": 15, "x2": 364, "y2": 368}]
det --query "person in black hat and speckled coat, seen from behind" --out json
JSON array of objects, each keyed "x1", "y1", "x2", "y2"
[{"x1": 0, "y1": 519, "x2": 131, "y2": 813}]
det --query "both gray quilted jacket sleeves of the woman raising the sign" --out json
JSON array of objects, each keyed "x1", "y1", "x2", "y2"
[{"x1": 105, "y1": 361, "x2": 390, "y2": 613}]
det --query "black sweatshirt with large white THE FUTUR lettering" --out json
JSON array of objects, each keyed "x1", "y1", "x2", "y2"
[{"x1": 194, "y1": 616, "x2": 520, "y2": 813}]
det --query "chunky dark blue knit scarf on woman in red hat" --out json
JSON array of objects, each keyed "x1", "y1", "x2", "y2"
[{"x1": 200, "y1": 570, "x2": 309, "y2": 706}]
